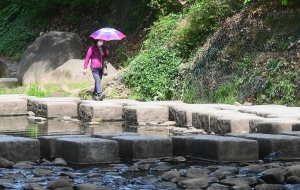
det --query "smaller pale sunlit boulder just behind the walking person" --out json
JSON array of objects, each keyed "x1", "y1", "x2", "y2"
[{"x1": 40, "y1": 59, "x2": 94, "y2": 84}]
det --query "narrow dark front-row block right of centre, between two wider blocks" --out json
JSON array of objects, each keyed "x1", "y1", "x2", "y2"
[{"x1": 172, "y1": 135, "x2": 198, "y2": 157}]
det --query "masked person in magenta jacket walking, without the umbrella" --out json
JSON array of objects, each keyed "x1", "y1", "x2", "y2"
[{"x1": 83, "y1": 40, "x2": 109, "y2": 101}]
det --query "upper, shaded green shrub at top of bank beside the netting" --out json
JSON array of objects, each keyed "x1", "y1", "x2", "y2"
[{"x1": 174, "y1": 0, "x2": 237, "y2": 57}]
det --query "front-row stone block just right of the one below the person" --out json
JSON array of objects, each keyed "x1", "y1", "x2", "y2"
[{"x1": 112, "y1": 135, "x2": 173, "y2": 160}]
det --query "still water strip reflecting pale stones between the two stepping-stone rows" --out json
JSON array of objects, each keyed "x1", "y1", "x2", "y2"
[{"x1": 0, "y1": 117, "x2": 171, "y2": 138}]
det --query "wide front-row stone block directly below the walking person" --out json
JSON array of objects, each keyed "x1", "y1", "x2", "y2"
[{"x1": 55, "y1": 137, "x2": 119, "y2": 164}]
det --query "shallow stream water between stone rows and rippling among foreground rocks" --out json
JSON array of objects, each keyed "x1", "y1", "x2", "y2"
[{"x1": 0, "y1": 117, "x2": 300, "y2": 190}]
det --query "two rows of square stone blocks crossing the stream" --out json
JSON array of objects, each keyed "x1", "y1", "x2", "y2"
[{"x1": 0, "y1": 94, "x2": 300, "y2": 164}]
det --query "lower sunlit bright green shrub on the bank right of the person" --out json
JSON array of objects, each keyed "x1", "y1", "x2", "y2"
[{"x1": 124, "y1": 14, "x2": 182, "y2": 100}]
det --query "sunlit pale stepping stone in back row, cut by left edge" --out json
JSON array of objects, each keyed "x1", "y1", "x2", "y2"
[{"x1": 0, "y1": 96, "x2": 28, "y2": 116}]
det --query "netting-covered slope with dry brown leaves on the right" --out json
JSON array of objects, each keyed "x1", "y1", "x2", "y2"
[{"x1": 186, "y1": 1, "x2": 300, "y2": 104}]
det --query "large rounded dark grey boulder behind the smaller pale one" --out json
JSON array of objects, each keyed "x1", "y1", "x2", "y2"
[{"x1": 17, "y1": 31, "x2": 82, "y2": 85}]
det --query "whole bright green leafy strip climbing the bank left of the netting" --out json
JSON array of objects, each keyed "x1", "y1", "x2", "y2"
[{"x1": 124, "y1": 0, "x2": 239, "y2": 101}]
